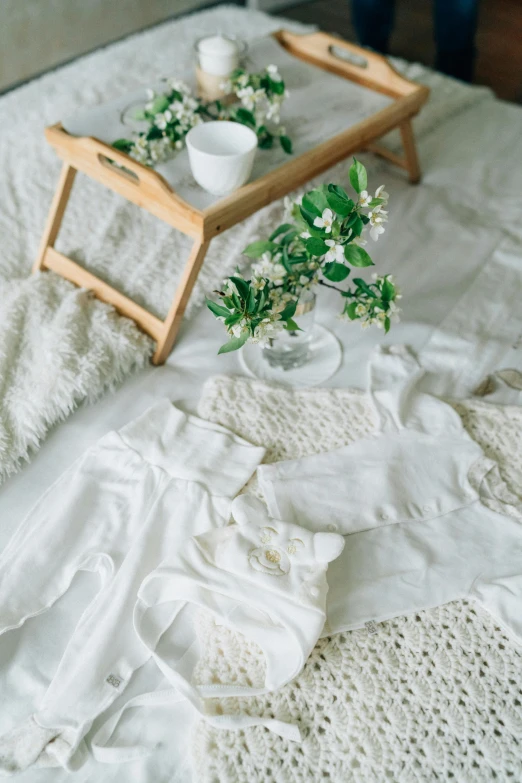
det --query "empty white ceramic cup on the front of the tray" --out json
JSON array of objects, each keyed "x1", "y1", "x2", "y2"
[{"x1": 186, "y1": 120, "x2": 257, "y2": 196}]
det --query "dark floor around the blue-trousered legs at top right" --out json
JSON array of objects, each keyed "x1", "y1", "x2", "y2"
[{"x1": 274, "y1": 0, "x2": 522, "y2": 103}]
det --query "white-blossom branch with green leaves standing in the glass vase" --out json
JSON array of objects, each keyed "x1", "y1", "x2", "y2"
[{"x1": 207, "y1": 158, "x2": 401, "y2": 353}]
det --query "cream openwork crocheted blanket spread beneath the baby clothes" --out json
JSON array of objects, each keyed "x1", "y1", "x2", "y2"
[{"x1": 192, "y1": 376, "x2": 522, "y2": 783}]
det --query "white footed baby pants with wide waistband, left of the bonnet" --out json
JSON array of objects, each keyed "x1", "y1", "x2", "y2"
[{"x1": 0, "y1": 400, "x2": 264, "y2": 773}]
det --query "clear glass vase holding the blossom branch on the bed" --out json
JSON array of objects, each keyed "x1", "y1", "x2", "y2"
[{"x1": 262, "y1": 291, "x2": 316, "y2": 370}]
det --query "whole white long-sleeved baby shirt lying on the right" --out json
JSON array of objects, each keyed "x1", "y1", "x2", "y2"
[{"x1": 258, "y1": 347, "x2": 522, "y2": 641}]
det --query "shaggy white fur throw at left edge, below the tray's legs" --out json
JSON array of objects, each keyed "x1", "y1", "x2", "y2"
[{"x1": 0, "y1": 272, "x2": 152, "y2": 481}]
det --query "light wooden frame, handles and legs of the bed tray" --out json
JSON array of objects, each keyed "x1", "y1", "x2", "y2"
[{"x1": 33, "y1": 30, "x2": 429, "y2": 364}]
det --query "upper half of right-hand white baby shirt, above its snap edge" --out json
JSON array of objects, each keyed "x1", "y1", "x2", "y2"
[{"x1": 258, "y1": 346, "x2": 482, "y2": 535}]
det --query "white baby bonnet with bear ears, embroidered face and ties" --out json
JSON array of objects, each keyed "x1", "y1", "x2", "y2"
[{"x1": 130, "y1": 495, "x2": 344, "y2": 740}]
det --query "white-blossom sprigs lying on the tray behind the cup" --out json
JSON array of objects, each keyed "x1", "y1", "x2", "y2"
[{"x1": 112, "y1": 65, "x2": 292, "y2": 167}]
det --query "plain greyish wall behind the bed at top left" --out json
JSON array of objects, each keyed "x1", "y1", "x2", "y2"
[{"x1": 0, "y1": 0, "x2": 210, "y2": 90}]
